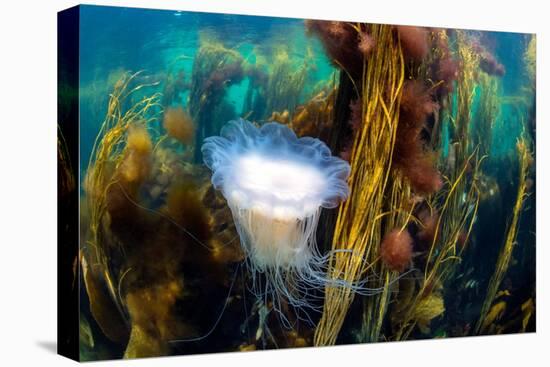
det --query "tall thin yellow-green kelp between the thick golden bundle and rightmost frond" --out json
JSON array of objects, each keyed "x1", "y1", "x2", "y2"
[{"x1": 392, "y1": 31, "x2": 484, "y2": 340}]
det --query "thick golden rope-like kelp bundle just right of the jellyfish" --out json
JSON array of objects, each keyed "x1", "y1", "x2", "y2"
[{"x1": 314, "y1": 25, "x2": 404, "y2": 345}]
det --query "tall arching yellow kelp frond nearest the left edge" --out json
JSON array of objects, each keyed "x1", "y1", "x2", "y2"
[{"x1": 84, "y1": 72, "x2": 161, "y2": 339}]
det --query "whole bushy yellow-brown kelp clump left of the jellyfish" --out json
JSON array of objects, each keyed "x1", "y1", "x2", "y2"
[{"x1": 81, "y1": 74, "x2": 242, "y2": 358}]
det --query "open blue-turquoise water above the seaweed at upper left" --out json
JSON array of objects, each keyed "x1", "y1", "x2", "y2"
[{"x1": 80, "y1": 6, "x2": 336, "y2": 172}]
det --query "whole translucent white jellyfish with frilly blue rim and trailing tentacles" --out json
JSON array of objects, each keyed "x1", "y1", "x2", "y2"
[{"x1": 201, "y1": 119, "x2": 350, "y2": 320}]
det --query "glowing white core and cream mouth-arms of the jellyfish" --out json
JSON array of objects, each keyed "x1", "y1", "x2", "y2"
[{"x1": 227, "y1": 153, "x2": 340, "y2": 270}]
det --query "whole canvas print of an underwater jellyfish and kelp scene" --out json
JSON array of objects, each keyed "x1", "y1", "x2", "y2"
[{"x1": 58, "y1": 6, "x2": 536, "y2": 361}]
